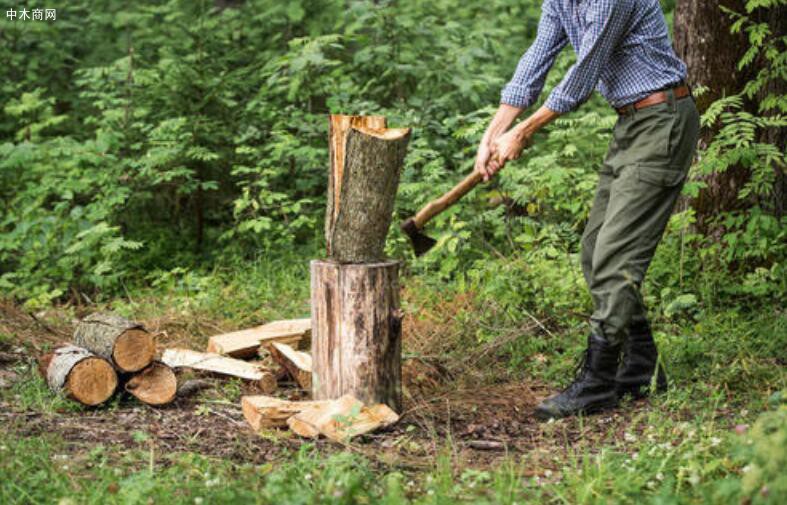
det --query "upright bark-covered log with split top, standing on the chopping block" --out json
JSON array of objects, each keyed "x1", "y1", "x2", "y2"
[{"x1": 325, "y1": 115, "x2": 410, "y2": 263}]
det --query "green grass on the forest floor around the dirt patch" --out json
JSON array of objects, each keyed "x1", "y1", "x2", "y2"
[{"x1": 0, "y1": 252, "x2": 787, "y2": 505}]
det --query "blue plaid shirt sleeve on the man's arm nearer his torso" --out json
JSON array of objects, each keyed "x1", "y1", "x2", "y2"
[{"x1": 544, "y1": 0, "x2": 629, "y2": 114}]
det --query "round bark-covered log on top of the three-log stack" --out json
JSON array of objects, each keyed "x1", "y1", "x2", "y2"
[{"x1": 74, "y1": 313, "x2": 156, "y2": 372}]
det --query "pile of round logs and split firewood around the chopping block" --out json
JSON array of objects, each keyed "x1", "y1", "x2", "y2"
[{"x1": 39, "y1": 313, "x2": 399, "y2": 441}]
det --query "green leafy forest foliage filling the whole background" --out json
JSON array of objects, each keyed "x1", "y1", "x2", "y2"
[{"x1": 0, "y1": 0, "x2": 787, "y2": 316}]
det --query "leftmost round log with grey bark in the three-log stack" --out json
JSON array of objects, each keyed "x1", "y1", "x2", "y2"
[{"x1": 39, "y1": 345, "x2": 118, "y2": 406}]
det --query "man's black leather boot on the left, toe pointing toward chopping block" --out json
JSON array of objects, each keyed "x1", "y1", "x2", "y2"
[{"x1": 535, "y1": 334, "x2": 621, "y2": 420}]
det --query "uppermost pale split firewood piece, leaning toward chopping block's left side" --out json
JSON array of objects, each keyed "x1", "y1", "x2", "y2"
[{"x1": 207, "y1": 319, "x2": 312, "y2": 358}]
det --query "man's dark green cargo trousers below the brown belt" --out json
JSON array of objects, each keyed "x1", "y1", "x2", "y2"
[{"x1": 582, "y1": 91, "x2": 699, "y2": 345}]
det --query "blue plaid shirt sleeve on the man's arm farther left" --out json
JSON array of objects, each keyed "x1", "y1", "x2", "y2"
[{"x1": 500, "y1": 0, "x2": 568, "y2": 109}]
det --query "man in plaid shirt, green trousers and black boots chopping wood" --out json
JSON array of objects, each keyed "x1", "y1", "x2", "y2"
[{"x1": 475, "y1": 0, "x2": 699, "y2": 419}]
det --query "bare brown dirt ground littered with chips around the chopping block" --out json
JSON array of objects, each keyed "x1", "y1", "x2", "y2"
[{"x1": 0, "y1": 304, "x2": 647, "y2": 472}]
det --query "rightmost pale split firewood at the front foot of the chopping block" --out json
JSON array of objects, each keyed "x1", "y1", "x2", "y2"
[{"x1": 287, "y1": 395, "x2": 399, "y2": 442}]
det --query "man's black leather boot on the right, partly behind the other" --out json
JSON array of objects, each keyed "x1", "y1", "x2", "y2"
[{"x1": 615, "y1": 322, "x2": 667, "y2": 398}]
